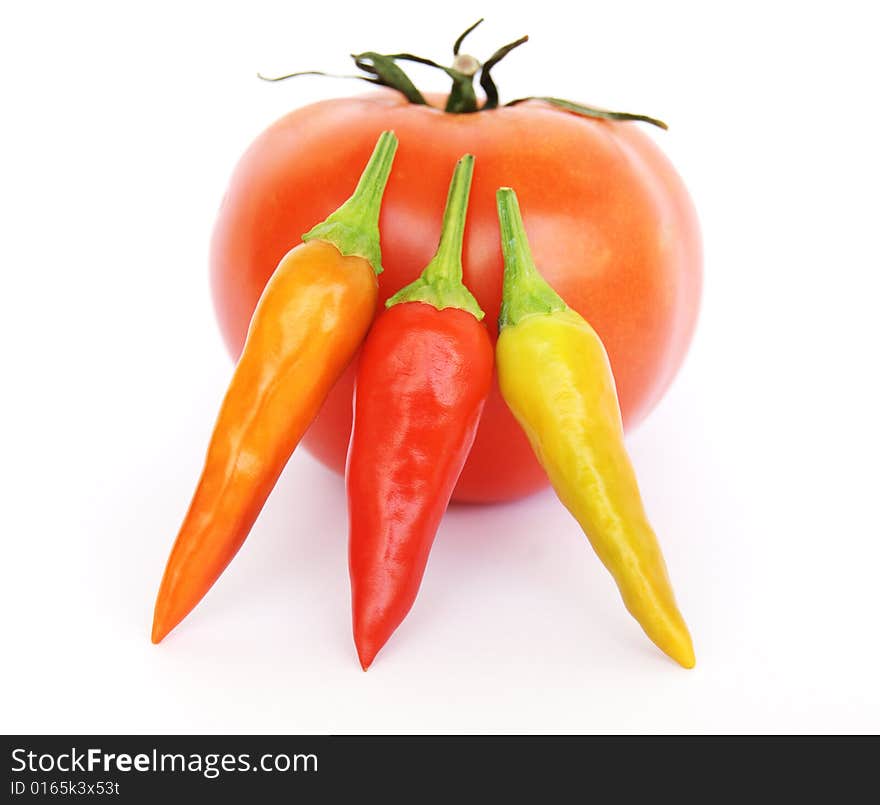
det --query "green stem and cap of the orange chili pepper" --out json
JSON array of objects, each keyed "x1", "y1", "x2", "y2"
[{"x1": 302, "y1": 131, "x2": 397, "y2": 274}]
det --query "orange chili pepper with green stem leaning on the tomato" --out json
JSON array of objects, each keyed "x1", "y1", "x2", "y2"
[{"x1": 152, "y1": 131, "x2": 397, "y2": 643}]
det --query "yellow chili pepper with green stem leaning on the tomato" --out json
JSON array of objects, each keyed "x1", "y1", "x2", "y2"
[{"x1": 496, "y1": 188, "x2": 695, "y2": 668}]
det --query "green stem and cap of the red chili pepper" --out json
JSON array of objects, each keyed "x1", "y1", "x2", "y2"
[{"x1": 385, "y1": 154, "x2": 486, "y2": 321}]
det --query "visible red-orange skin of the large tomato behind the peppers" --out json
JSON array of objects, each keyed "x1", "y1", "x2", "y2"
[{"x1": 211, "y1": 92, "x2": 702, "y2": 502}]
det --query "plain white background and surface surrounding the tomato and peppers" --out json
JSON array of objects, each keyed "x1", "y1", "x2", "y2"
[{"x1": 0, "y1": 0, "x2": 880, "y2": 733}]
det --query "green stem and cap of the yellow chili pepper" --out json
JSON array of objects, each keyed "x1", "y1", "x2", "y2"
[{"x1": 495, "y1": 187, "x2": 567, "y2": 332}]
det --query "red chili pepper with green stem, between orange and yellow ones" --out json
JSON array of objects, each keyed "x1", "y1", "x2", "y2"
[{"x1": 346, "y1": 155, "x2": 494, "y2": 670}]
